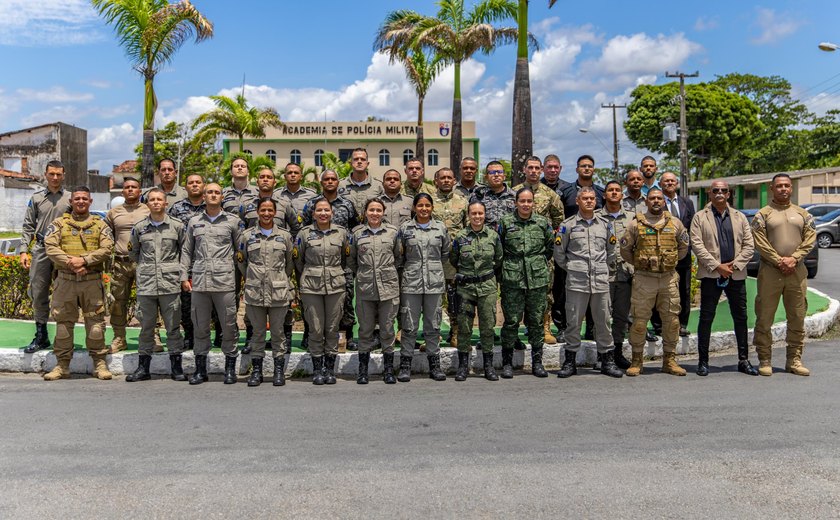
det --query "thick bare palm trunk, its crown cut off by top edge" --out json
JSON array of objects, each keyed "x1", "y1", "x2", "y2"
[{"x1": 510, "y1": 0, "x2": 557, "y2": 185}]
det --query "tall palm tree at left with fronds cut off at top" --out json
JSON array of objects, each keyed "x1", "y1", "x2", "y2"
[{"x1": 91, "y1": 0, "x2": 213, "y2": 187}]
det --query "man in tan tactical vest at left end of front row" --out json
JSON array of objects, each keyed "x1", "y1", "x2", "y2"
[{"x1": 44, "y1": 186, "x2": 114, "y2": 381}]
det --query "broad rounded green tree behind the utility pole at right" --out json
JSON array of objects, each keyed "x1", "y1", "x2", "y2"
[{"x1": 624, "y1": 83, "x2": 762, "y2": 176}]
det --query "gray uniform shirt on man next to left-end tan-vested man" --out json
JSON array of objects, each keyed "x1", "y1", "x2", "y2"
[{"x1": 128, "y1": 215, "x2": 185, "y2": 296}]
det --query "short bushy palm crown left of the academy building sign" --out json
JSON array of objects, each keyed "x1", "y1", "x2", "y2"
[{"x1": 192, "y1": 94, "x2": 284, "y2": 152}]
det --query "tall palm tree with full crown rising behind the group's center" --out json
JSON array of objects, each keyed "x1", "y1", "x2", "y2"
[{"x1": 374, "y1": 0, "x2": 519, "y2": 179}]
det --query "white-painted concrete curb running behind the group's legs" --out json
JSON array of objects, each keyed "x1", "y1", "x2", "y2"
[{"x1": 0, "y1": 289, "x2": 840, "y2": 377}]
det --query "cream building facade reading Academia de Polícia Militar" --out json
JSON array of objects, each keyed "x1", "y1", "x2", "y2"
[{"x1": 222, "y1": 121, "x2": 479, "y2": 179}]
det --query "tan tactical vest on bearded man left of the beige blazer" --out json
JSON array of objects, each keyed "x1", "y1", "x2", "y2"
[{"x1": 633, "y1": 212, "x2": 679, "y2": 273}]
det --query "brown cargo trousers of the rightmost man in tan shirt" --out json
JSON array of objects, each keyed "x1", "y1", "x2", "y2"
[{"x1": 753, "y1": 262, "x2": 808, "y2": 361}]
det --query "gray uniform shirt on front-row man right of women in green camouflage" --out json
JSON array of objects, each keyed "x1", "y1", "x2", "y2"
[{"x1": 554, "y1": 211, "x2": 616, "y2": 293}]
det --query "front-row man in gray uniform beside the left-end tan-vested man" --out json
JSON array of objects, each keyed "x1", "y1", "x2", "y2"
[{"x1": 125, "y1": 188, "x2": 187, "y2": 382}]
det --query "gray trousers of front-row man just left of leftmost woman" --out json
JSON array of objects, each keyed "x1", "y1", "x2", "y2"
[{"x1": 191, "y1": 291, "x2": 236, "y2": 357}]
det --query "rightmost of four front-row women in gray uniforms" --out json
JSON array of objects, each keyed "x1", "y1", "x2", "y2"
[{"x1": 397, "y1": 193, "x2": 451, "y2": 383}]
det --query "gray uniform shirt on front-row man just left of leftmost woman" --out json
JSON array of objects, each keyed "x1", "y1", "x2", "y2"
[{"x1": 181, "y1": 210, "x2": 244, "y2": 292}]
